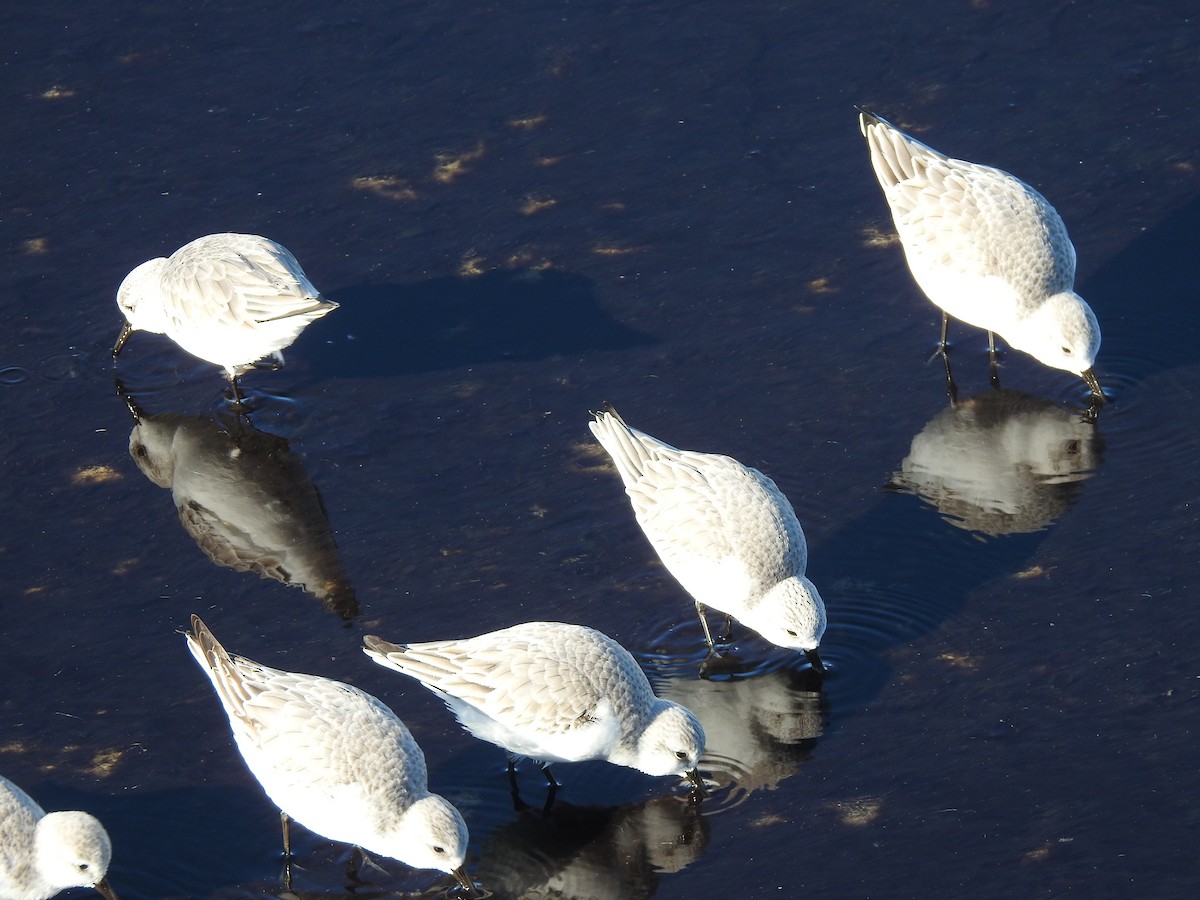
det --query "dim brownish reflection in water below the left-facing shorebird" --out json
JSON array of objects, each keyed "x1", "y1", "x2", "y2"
[{"x1": 122, "y1": 395, "x2": 359, "y2": 622}]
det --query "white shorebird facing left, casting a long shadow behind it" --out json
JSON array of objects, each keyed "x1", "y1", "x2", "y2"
[{"x1": 113, "y1": 234, "x2": 337, "y2": 395}]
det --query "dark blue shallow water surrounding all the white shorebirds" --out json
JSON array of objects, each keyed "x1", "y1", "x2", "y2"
[{"x1": 0, "y1": 0, "x2": 1200, "y2": 900}]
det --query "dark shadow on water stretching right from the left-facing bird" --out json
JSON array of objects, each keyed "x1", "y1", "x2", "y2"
[{"x1": 301, "y1": 269, "x2": 654, "y2": 378}]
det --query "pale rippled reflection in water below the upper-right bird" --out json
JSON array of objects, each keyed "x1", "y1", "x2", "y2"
[{"x1": 888, "y1": 389, "x2": 1103, "y2": 536}]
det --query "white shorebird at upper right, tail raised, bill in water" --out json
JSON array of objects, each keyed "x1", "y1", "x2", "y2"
[{"x1": 859, "y1": 109, "x2": 1104, "y2": 402}]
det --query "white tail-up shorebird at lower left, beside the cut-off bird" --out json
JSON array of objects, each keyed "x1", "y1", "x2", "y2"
[{"x1": 186, "y1": 616, "x2": 474, "y2": 895}]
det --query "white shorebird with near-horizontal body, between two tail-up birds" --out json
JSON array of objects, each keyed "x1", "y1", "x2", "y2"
[{"x1": 362, "y1": 622, "x2": 704, "y2": 790}]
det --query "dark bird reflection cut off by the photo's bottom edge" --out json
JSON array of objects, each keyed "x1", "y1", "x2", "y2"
[{"x1": 475, "y1": 794, "x2": 709, "y2": 900}]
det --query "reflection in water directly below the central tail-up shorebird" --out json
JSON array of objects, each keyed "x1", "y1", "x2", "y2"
[{"x1": 655, "y1": 654, "x2": 828, "y2": 808}]
